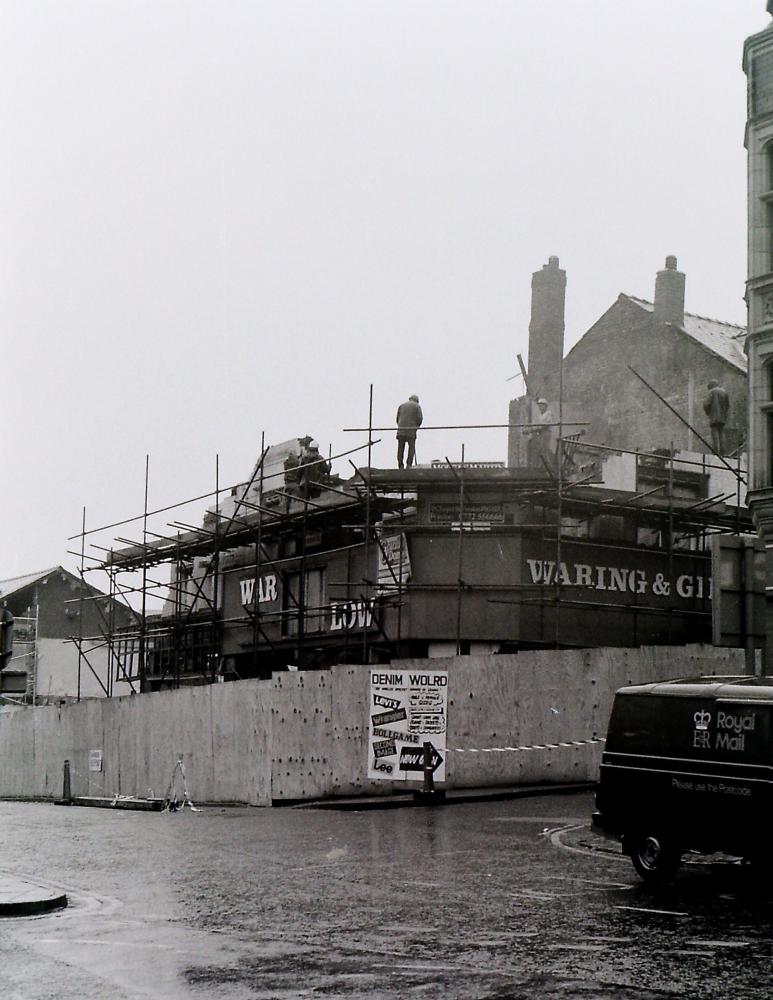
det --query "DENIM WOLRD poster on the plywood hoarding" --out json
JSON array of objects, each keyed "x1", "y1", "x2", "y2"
[{"x1": 368, "y1": 667, "x2": 448, "y2": 782}]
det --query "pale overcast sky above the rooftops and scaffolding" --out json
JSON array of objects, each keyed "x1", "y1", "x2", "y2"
[{"x1": 0, "y1": 0, "x2": 769, "y2": 582}]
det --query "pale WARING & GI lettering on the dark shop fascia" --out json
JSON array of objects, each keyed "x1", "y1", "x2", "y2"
[{"x1": 526, "y1": 559, "x2": 711, "y2": 600}]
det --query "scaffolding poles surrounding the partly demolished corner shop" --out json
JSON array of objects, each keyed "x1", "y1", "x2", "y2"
[{"x1": 72, "y1": 382, "x2": 743, "y2": 698}]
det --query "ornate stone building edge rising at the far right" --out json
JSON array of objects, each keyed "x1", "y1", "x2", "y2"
[{"x1": 743, "y1": 2, "x2": 773, "y2": 673}]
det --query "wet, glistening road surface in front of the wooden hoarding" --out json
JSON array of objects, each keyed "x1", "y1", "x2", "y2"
[{"x1": 0, "y1": 794, "x2": 773, "y2": 1000}]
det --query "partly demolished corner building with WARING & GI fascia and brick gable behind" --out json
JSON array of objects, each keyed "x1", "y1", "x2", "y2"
[{"x1": 74, "y1": 258, "x2": 751, "y2": 691}]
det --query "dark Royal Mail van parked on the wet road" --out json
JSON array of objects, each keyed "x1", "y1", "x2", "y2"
[{"x1": 593, "y1": 677, "x2": 773, "y2": 882}]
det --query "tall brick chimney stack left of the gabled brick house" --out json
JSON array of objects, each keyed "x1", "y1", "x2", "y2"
[{"x1": 528, "y1": 257, "x2": 566, "y2": 396}]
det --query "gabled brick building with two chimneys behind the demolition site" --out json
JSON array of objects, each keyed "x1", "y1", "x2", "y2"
[{"x1": 508, "y1": 257, "x2": 747, "y2": 466}]
